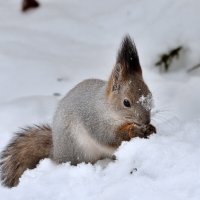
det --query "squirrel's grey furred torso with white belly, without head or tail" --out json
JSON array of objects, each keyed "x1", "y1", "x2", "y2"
[{"x1": 52, "y1": 79, "x2": 118, "y2": 164}]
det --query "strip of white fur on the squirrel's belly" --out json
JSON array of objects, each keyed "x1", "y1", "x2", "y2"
[{"x1": 72, "y1": 124, "x2": 115, "y2": 161}]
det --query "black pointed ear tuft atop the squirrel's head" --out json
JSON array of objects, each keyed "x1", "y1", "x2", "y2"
[{"x1": 116, "y1": 35, "x2": 142, "y2": 74}]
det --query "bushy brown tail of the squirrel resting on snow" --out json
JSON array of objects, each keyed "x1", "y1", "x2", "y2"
[{"x1": 0, "y1": 125, "x2": 52, "y2": 187}]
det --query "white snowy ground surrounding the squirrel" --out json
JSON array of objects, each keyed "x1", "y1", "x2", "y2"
[{"x1": 0, "y1": 0, "x2": 200, "y2": 200}]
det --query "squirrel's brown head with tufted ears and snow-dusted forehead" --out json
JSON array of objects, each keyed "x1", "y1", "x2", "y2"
[{"x1": 106, "y1": 36, "x2": 152, "y2": 125}]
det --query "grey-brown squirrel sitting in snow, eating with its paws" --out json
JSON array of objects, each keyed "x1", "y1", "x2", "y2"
[{"x1": 0, "y1": 35, "x2": 156, "y2": 187}]
